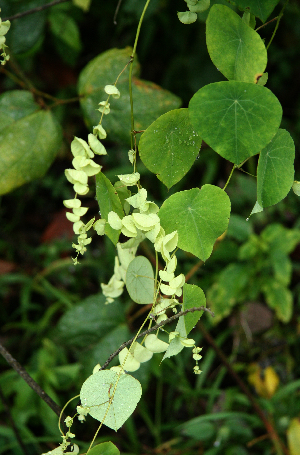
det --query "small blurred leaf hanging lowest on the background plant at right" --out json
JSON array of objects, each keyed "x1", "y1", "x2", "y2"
[{"x1": 263, "y1": 280, "x2": 293, "y2": 323}]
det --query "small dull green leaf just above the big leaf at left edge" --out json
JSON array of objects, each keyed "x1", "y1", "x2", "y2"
[{"x1": 0, "y1": 90, "x2": 40, "y2": 131}]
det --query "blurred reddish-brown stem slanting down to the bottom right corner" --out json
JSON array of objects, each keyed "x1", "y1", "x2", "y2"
[{"x1": 197, "y1": 322, "x2": 289, "y2": 455}]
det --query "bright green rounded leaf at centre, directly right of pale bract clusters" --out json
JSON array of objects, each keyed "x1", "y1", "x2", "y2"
[{"x1": 158, "y1": 185, "x2": 230, "y2": 261}]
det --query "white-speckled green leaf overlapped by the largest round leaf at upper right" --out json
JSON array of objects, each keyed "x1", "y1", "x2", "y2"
[{"x1": 139, "y1": 109, "x2": 202, "y2": 188}]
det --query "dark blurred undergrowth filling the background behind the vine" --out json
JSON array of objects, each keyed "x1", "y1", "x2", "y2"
[{"x1": 0, "y1": 0, "x2": 300, "y2": 455}]
